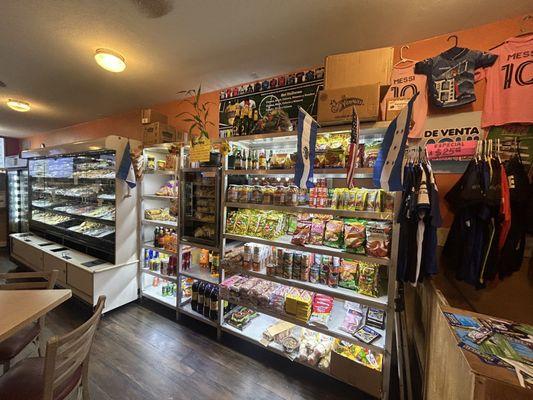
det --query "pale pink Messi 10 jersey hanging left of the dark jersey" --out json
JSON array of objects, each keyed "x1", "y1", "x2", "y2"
[{"x1": 381, "y1": 63, "x2": 428, "y2": 139}]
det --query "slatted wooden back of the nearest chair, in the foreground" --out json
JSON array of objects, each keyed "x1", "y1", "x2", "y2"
[{"x1": 43, "y1": 296, "x2": 105, "y2": 400}]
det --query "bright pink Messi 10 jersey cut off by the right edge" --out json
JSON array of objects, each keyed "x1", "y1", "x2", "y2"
[{"x1": 479, "y1": 34, "x2": 533, "y2": 128}]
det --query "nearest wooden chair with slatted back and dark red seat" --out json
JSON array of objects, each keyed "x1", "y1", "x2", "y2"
[{"x1": 0, "y1": 296, "x2": 105, "y2": 400}]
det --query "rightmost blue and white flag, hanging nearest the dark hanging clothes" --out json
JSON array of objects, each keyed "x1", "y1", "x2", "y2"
[{"x1": 373, "y1": 93, "x2": 418, "y2": 192}]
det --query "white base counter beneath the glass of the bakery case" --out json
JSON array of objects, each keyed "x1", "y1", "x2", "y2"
[{"x1": 10, "y1": 233, "x2": 138, "y2": 312}]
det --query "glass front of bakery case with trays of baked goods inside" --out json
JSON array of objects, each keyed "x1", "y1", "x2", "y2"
[{"x1": 28, "y1": 151, "x2": 116, "y2": 263}]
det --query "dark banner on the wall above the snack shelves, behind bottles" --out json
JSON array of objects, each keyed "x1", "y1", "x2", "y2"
[{"x1": 219, "y1": 67, "x2": 324, "y2": 130}]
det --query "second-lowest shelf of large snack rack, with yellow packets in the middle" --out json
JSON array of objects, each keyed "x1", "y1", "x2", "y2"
[{"x1": 220, "y1": 275, "x2": 385, "y2": 354}]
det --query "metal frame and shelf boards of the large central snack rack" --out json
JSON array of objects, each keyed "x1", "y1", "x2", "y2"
[{"x1": 219, "y1": 122, "x2": 401, "y2": 398}]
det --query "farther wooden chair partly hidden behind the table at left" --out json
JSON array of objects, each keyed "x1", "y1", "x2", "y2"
[{"x1": 0, "y1": 269, "x2": 59, "y2": 373}]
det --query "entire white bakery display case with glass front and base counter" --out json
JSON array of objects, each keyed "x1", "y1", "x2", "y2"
[{"x1": 10, "y1": 136, "x2": 141, "y2": 312}]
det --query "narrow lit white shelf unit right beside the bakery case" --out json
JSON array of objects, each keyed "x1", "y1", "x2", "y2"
[{"x1": 139, "y1": 143, "x2": 182, "y2": 309}]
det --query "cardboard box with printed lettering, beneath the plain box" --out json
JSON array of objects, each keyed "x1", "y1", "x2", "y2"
[{"x1": 317, "y1": 83, "x2": 381, "y2": 125}]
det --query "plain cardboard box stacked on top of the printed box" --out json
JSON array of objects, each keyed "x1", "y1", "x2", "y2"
[{"x1": 324, "y1": 47, "x2": 394, "y2": 90}]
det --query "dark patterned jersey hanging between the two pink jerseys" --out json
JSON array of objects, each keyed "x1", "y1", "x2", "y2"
[{"x1": 415, "y1": 47, "x2": 497, "y2": 108}]
